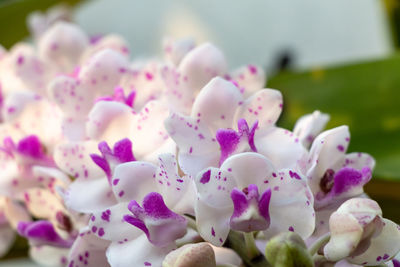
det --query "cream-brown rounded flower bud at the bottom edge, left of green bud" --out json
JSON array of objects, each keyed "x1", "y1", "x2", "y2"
[{"x1": 162, "y1": 242, "x2": 216, "y2": 267}]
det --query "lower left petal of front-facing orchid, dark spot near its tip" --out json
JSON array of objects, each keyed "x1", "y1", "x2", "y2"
[{"x1": 195, "y1": 199, "x2": 233, "y2": 247}]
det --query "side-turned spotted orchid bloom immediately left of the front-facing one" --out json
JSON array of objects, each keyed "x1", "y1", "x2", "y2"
[{"x1": 85, "y1": 154, "x2": 195, "y2": 266}]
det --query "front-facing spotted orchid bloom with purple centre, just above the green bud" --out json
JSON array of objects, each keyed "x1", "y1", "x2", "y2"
[{"x1": 195, "y1": 152, "x2": 315, "y2": 246}]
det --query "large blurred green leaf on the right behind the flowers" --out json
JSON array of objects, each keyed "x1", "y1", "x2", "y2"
[{"x1": 268, "y1": 55, "x2": 400, "y2": 180}]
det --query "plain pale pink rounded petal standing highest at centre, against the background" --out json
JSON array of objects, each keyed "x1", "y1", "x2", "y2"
[{"x1": 178, "y1": 43, "x2": 227, "y2": 92}]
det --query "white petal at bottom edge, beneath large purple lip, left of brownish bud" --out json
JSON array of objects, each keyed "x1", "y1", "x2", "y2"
[{"x1": 106, "y1": 234, "x2": 175, "y2": 267}]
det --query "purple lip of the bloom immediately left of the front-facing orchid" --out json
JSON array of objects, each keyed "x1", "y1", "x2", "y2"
[{"x1": 124, "y1": 192, "x2": 187, "y2": 247}]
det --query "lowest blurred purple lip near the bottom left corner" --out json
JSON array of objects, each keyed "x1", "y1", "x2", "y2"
[{"x1": 17, "y1": 221, "x2": 73, "y2": 248}]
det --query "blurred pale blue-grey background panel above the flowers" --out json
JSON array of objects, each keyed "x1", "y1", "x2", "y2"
[{"x1": 75, "y1": 0, "x2": 392, "y2": 71}]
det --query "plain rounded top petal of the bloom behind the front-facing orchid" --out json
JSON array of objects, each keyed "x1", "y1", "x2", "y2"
[{"x1": 191, "y1": 77, "x2": 243, "y2": 134}]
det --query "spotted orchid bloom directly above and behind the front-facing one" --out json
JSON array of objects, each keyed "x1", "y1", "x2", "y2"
[{"x1": 165, "y1": 78, "x2": 306, "y2": 176}]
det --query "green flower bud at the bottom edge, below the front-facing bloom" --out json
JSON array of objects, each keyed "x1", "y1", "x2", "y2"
[{"x1": 265, "y1": 232, "x2": 314, "y2": 267}]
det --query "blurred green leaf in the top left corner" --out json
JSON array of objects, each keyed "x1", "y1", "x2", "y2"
[{"x1": 0, "y1": 0, "x2": 81, "y2": 48}]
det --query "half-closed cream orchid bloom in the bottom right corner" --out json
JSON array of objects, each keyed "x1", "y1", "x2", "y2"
[{"x1": 324, "y1": 198, "x2": 400, "y2": 266}]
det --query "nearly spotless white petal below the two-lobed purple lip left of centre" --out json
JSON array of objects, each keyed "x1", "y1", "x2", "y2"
[{"x1": 64, "y1": 176, "x2": 117, "y2": 213}]
